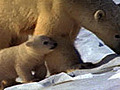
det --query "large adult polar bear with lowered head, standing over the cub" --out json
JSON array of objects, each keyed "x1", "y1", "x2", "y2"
[{"x1": 0, "y1": 0, "x2": 120, "y2": 74}]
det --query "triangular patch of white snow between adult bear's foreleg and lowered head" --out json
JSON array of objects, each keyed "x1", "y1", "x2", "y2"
[{"x1": 75, "y1": 28, "x2": 115, "y2": 63}]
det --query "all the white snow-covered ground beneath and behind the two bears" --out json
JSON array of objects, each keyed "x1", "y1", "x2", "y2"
[{"x1": 5, "y1": 0, "x2": 120, "y2": 90}]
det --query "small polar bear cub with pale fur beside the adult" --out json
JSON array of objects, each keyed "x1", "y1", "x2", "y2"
[{"x1": 0, "y1": 36, "x2": 56, "y2": 86}]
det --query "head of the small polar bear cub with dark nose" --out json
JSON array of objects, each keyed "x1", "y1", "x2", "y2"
[{"x1": 26, "y1": 35, "x2": 57, "y2": 54}]
